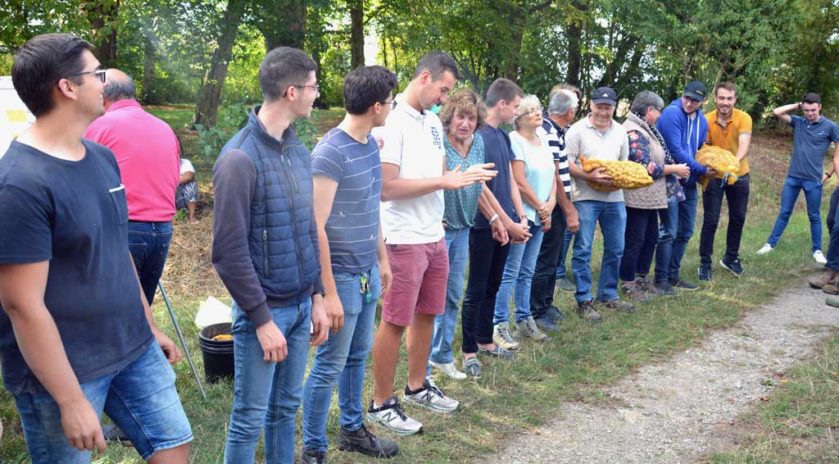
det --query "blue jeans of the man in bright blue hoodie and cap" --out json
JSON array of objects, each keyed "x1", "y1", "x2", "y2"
[{"x1": 655, "y1": 184, "x2": 699, "y2": 282}]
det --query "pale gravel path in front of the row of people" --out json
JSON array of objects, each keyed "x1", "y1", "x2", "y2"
[{"x1": 481, "y1": 282, "x2": 839, "y2": 464}]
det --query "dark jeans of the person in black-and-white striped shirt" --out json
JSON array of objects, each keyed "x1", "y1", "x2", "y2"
[{"x1": 530, "y1": 206, "x2": 567, "y2": 319}]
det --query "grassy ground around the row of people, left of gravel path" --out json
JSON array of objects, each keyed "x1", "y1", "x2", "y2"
[{"x1": 0, "y1": 125, "x2": 839, "y2": 464}]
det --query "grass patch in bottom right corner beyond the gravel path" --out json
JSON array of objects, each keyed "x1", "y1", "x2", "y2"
[{"x1": 709, "y1": 334, "x2": 839, "y2": 464}]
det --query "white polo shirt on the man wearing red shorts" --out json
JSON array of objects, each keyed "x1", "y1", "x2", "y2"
[{"x1": 374, "y1": 95, "x2": 446, "y2": 244}]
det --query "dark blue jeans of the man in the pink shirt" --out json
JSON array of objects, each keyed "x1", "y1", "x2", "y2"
[{"x1": 128, "y1": 221, "x2": 172, "y2": 304}]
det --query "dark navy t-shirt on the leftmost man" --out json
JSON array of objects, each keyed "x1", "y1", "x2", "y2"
[{"x1": 0, "y1": 141, "x2": 153, "y2": 393}]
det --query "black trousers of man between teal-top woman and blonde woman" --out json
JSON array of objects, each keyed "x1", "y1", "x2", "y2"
[{"x1": 460, "y1": 229, "x2": 510, "y2": 353}]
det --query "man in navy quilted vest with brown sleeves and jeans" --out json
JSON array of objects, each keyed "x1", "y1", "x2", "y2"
[{"x1": 212, "y1": 47, "x2": 329, "y2": 464}]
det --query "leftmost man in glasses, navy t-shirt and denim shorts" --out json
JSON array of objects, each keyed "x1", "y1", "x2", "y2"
[{"x1": 0, "y1": 34, "x2": 192, "y2": 464}]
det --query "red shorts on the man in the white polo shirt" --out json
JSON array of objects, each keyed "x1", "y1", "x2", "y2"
[{"x1": 382, "y1": 238, "x2": 449, "y2": 327}]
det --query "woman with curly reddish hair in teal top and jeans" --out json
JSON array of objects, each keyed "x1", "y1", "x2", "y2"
[{"x1": 428, "y1": 89, "x2": 486, "y2": 380}]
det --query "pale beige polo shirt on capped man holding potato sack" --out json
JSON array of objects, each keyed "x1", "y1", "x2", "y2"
[{"x1": 565, "y1": 117, "x2": 629, "y2": 202}]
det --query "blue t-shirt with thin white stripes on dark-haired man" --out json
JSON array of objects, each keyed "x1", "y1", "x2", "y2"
[{"x1": 312, "y1": 127, "x2": 382, "y2": 274}]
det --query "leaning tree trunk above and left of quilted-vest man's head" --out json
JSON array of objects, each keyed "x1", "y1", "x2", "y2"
[{"x1": 192, "y1": 1, "x2": 245, "y2": 127}]
